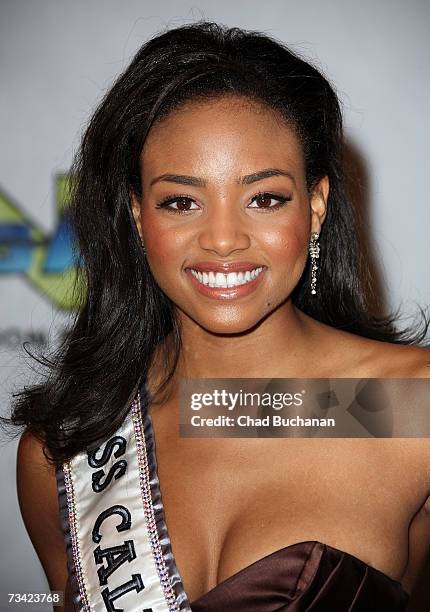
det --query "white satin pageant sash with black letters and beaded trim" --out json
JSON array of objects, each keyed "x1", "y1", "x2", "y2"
[{"x1": 57, "y1": 384, "x2": 191, "y2": 612}]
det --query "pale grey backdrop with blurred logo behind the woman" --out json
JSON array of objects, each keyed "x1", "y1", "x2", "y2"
[{"x1": 0, "y1": 0, "x2": 430, "y2": 610}]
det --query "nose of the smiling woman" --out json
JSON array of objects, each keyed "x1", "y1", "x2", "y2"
[{"x1": 198, "y1": 201, "x2": 251, "y2": 257}]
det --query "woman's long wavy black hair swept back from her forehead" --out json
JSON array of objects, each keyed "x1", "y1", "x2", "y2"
[{"x1": 4, "y1": 22, "x2": 429, "y2": 465}]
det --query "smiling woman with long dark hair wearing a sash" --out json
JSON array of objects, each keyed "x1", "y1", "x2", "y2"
[{"x1": 9, "y1": 23, "x2": 430, "y2": 612}]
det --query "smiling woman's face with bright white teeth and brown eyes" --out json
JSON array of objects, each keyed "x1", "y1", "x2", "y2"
[{"x1": 132, "y1": 96, "x2": 328, "y2": 333}]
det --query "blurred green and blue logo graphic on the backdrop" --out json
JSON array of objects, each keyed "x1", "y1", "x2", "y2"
[{"x1": 0, "y1": 174, "x2": 77, "y2": 310}]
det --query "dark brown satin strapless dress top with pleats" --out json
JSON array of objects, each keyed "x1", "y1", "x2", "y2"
[{"x1": 191, "y1": 541, "x2": 409, "y2": 612}]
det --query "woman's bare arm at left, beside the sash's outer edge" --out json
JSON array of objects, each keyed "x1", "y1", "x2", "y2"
[{"x1": 16, "y1": 432, "x2": 68, "y2": 611}]
